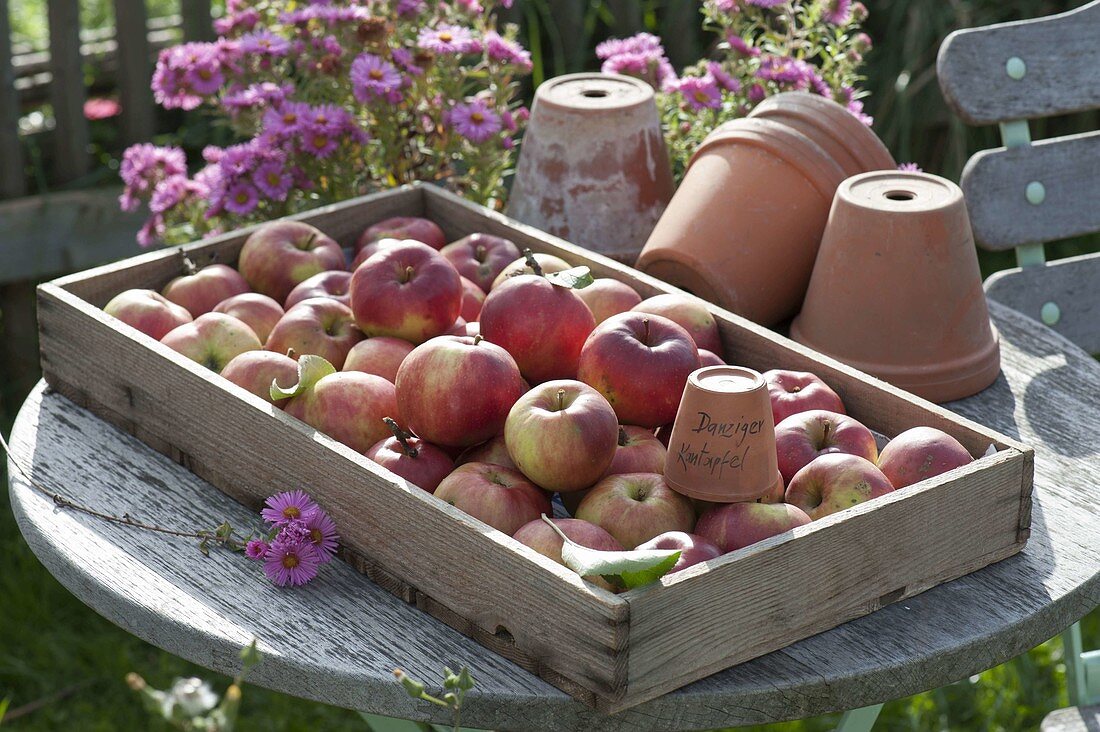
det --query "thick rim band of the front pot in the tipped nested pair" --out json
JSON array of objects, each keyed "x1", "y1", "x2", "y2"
[{"x1": 685, "y1": 118, "x2": 848, "y2": 201}]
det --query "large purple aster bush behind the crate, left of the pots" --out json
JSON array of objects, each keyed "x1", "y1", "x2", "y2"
[{"x1": 120, "y1": 0, "x2": 531, "y2": 245}]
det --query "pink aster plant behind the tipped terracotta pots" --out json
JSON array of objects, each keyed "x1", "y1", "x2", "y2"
[{"x1": 596, "y1": 0, "x2": 873, "y2": 179}]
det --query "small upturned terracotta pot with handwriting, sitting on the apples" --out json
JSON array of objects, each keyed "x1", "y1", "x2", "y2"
[{"x1": 664, "y1": 365, "x2": 783, "y2": 503}]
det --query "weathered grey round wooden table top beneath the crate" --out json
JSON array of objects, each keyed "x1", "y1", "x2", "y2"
[{"x1": 9, "y1": 303, "x2": 1100, "y2": 730}]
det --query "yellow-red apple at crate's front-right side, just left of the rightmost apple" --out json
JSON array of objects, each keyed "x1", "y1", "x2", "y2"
[{"x1": 784, "y1": 454, "x2": 894, "y2": 520}]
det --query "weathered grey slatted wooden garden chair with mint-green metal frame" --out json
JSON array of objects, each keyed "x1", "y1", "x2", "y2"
[{"x1": 937, "y1": 0, "x2": 1100, "y2": 732}]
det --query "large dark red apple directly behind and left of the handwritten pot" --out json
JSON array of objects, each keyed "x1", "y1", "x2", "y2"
[{"x1": 576, "y1": 312, "x2": 699, "y2": 427}]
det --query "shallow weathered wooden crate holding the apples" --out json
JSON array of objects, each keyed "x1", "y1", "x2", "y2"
[{"x1": 32, "y1": 186, "x2": 1033, "y2": 712}]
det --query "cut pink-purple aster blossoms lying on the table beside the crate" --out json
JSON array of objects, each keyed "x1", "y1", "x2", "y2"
[{"x1": 244, "y1": 491, "x2": 340, "y2": 587}]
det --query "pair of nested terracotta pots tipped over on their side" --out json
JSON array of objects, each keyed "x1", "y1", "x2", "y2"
[{"x1": 637, "y1": 92, "x2": 897, "y2": 326}]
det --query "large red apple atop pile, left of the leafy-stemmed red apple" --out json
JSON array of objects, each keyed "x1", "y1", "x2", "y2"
[{"x1": 351, "y1": 241, "x2": 462, "y2": 343}]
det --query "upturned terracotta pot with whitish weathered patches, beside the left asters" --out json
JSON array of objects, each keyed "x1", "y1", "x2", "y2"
[{"x1": 507, "y1": 74, "x2": 673, "y2": 262}]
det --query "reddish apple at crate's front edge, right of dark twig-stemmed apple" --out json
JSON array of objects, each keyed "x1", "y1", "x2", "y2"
[{"x1": 436, "y1": 462, "x2": 551, "y2": 536}]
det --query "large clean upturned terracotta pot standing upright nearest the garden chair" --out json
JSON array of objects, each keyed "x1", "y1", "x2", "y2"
[{"x1": 791, "y1": 171, "x2": 1001, "y2": 402}]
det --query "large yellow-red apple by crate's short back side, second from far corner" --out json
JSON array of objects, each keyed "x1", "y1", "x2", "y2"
[{"x1": 237, "y1": 221, "x2": 345, "y2": 303}]
